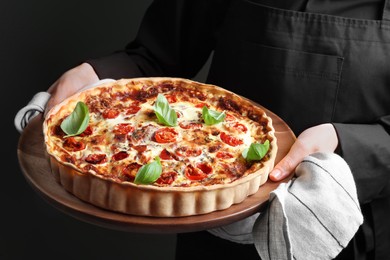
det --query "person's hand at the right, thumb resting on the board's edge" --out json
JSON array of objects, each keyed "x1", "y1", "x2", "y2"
[{"x1": 269, "y1": 123, "x2": 338, "y2": 181}]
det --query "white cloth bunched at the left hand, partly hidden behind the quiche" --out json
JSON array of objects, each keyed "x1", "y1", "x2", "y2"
[{"x1": 14, "y1": 79, "x2": 115, "y2": 133}]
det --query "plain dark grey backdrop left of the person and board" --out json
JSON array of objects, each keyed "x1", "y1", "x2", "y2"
[{"x1": 0, "y1": 0, "x2": 207, "y2": 260}]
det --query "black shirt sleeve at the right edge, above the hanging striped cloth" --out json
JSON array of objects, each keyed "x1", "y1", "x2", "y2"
[{"x1": 333, "y1": 115, "x2": 390, "y2": 204}]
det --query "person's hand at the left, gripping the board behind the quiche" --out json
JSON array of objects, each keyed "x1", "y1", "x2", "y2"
[{"x1": 45, "y1": 63, "x2": 99, "y2": 115}]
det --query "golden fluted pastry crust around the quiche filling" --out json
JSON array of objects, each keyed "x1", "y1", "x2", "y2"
[{"x1": 43, "y1": 78, "x2": 277, "y2": 217}]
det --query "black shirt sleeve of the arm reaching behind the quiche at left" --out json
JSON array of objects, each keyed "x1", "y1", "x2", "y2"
[{"x1": 86, "y1": 0, "x2": 229, "y2": 79}]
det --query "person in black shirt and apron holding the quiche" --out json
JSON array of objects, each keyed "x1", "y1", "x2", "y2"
[{"x1": 42, "y1": 0, "x2": 390, "y2": 259}]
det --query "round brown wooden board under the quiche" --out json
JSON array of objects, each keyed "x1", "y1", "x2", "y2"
[{"x1": 18, "y1": 105, "x2": 295, "y2": 233}]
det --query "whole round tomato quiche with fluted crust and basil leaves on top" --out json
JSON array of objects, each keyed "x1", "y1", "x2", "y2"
[{"x1": 43, "y1": 77, "x2": 277, "y2": 217}]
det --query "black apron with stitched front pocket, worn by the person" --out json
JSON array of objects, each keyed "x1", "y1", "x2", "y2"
[{"x1": 207, "y1": 0, "x2": 390, "y2": 259}]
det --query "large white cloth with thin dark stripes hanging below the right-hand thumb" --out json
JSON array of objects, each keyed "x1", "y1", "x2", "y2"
[{"x1": 209, "y1": 153, "x2": 363, "y2": 260}]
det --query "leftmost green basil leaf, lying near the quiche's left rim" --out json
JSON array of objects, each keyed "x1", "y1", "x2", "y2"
[{"x1": 61, "y1": 101, "x2": 89, "y2": 137}]
